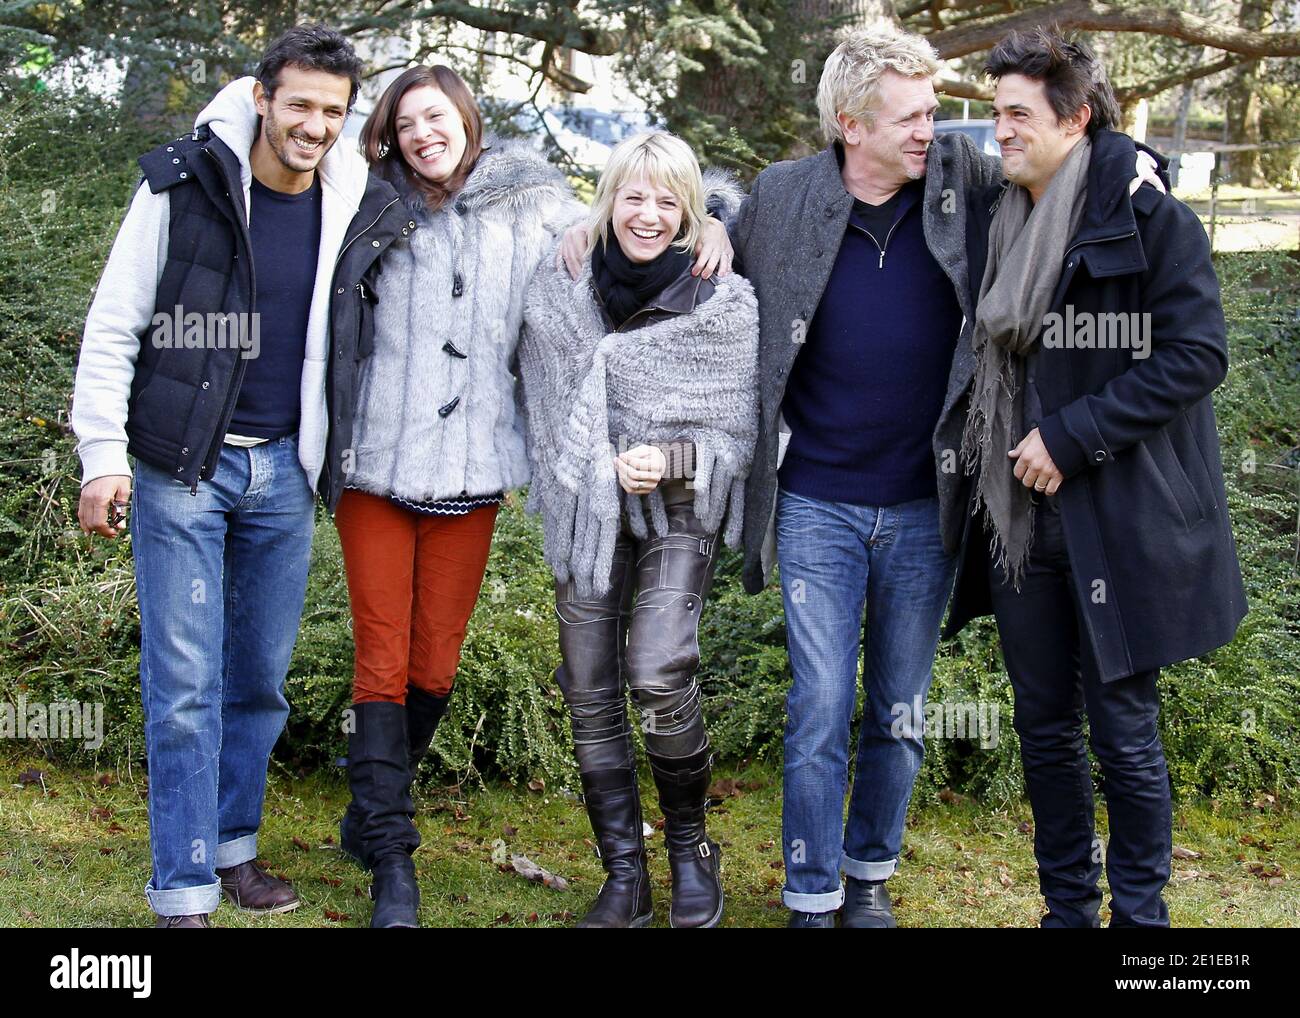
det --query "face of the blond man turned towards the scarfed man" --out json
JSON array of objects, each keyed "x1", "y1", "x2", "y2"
[{"x1": 841, "y1": 69, "x2": 939, "y2": 187}]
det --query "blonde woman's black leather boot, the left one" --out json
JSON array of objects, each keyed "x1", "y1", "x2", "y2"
[{"x1": 577, "y1": 767, "x2": 654, "y2": 930}]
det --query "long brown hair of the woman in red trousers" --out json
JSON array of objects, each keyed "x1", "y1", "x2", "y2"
[{"x1": 361, "y1": 64, "x2": 484, "y2": 212}]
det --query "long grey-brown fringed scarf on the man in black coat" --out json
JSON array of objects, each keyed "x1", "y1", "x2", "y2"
[{"x1": 962, "y1": 137, "x2": 1092, "y2": 589}]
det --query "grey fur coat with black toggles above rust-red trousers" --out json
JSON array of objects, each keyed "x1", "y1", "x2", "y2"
[{"x1": 345, "y1": 142, "x2": 586, "y2": 501}]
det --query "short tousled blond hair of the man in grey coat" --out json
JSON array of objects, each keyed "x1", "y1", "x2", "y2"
[{"x1": 816, "y1": 25, "x2": 940, "y2": 143}]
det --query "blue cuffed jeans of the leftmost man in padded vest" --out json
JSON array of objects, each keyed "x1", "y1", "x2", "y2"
[{"x1": 131, "y1": 436, "x2": 315, "y2": 915}]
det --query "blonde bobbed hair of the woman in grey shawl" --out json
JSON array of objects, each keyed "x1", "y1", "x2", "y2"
[{"x1": 586, "y1": 131, "x2": 709, "y2": 256}]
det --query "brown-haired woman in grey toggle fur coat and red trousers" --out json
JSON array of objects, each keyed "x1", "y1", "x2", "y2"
[{"x1": 335, "y1": 66, "x2": 585, "y2": 926}]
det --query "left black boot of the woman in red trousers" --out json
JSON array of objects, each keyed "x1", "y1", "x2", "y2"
[{"x1": 347, "y1": 702, "x2": 420, "y2": 927}]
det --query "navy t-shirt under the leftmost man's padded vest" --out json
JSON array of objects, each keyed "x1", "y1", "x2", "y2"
[{"x1": 228, "y1": 174, "x2": 321, "y2": 438}]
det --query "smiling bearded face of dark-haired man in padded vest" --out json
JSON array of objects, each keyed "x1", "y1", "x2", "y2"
[{"x1": 252, "y1": 64, "x2": 352, "y2": 174}]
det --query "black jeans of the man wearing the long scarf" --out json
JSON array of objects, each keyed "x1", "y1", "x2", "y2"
[{"x1": 989, "y1": 497, "x2": 1173, "y2": 926}]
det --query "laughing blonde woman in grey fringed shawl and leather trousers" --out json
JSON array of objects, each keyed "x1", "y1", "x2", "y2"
[{"x1": 519, "y1": 131, "x2": 758, "y2": 927}]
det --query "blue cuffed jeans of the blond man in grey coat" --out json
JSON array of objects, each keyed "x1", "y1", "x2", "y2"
[{"x1": 776, "y1": 490, "x2": 956, "y2": 911}]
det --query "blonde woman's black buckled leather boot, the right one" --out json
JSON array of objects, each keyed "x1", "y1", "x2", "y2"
[{"x1": 649, "y1": 746, "x2": 723, "y2": 928}]
